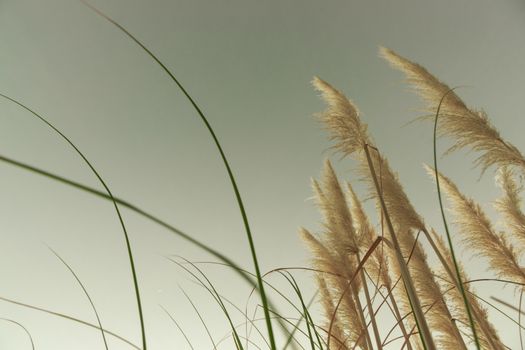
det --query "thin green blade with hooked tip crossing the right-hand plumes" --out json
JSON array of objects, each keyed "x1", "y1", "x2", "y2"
[{"x1": 433, "y1": 88, "x2": 481, "y2": 350}]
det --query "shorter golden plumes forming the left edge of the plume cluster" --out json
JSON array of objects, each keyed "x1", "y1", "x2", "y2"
[{"x1": 301, "y1": 162, "x2": 369, "y2": 349}]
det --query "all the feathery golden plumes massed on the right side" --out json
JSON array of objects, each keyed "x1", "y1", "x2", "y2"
[{"x1": 301, "y1": 49, "x2": 525, "y2": 350}]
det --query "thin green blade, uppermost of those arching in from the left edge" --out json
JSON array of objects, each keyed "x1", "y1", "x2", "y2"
[{"x1": 0, "y1": 93, "x2": 147, "y2": 350}]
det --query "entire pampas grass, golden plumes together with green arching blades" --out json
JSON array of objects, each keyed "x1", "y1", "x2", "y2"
[{"x1": 0, "y1": 0, "x2": 525, "y2": 350}]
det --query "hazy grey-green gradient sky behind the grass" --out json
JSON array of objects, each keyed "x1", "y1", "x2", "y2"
[{"x1": 0, "y1": 0, "x2": 525, "y2": 350}]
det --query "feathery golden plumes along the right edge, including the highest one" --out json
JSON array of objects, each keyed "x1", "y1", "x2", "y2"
[{"x1": 380, "y1": 48, "x2": 525, "y2": 290}]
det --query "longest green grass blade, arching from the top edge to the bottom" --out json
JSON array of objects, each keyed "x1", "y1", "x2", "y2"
[{"x1": 79, "y1": 0, "x2": 277, "y2": 350}]
